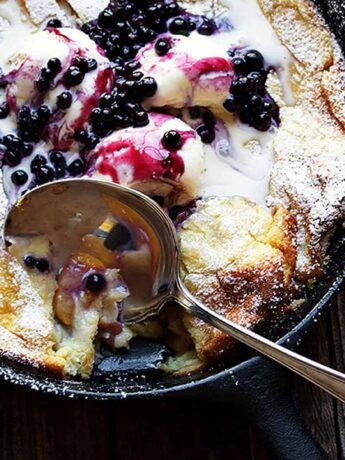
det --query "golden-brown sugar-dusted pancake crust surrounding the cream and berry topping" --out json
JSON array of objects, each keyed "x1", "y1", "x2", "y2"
[{"x1": 0, "y1": 0, "x2": 345, "y2": 377}]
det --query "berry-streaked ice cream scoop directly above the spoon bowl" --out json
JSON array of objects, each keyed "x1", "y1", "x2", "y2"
[{"x1": 89, "y1": 112, "x2": 204, "y2": 203}]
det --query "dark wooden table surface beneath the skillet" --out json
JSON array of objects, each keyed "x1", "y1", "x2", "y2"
[{"x1": 0, "y1": 291, "x2": 345, "y2": 460}]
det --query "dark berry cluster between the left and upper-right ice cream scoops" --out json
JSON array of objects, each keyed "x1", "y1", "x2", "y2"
[{"x1": 76, "y1": 61, "x2": 157, "y2": 145}]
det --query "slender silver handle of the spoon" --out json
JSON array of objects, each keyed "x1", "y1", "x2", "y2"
[{"x1": 176, "y1": 279, "x2": 345, "y2": 402}]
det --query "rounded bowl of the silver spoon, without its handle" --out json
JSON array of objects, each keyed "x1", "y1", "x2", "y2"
[{"x1": 4, "y1": 179, "x2": 178, "y2": 322}]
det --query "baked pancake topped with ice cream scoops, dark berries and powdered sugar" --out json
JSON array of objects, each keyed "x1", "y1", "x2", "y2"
[{"x1": 0, "y1": 0, "x2": 345, "y2": 378}]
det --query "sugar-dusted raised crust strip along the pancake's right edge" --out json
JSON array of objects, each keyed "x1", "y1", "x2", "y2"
[{"x1": 259, "y1": 0, "x2": 345, "y2": 281}]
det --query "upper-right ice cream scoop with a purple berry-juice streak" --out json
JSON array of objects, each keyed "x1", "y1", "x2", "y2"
[{"x1": 137, "y1": 32, "x2": 234, "y2": 108}]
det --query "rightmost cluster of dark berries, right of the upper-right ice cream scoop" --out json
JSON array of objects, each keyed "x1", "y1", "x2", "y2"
[{"x1": 224, "y1": 50, "x2": 279, "y2": 131}]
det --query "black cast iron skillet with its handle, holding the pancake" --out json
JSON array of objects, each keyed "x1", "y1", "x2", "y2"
[{"x1": 0, "y1": 0, "x2": 345, "y2": 460}]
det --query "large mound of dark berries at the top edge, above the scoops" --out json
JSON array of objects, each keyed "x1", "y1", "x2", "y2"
[{"x1": 82, "y1": 0, "x2": 215, "y2": 66}]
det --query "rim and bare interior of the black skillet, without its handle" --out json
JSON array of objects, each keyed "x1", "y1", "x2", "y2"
[{"x1": 0, "y1": 0, "x2": 345, "y2": 399}]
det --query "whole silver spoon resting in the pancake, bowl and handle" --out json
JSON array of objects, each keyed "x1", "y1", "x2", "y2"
[{"x1": 4, "y1": 179, "x2": 345, "y2": 402}]
